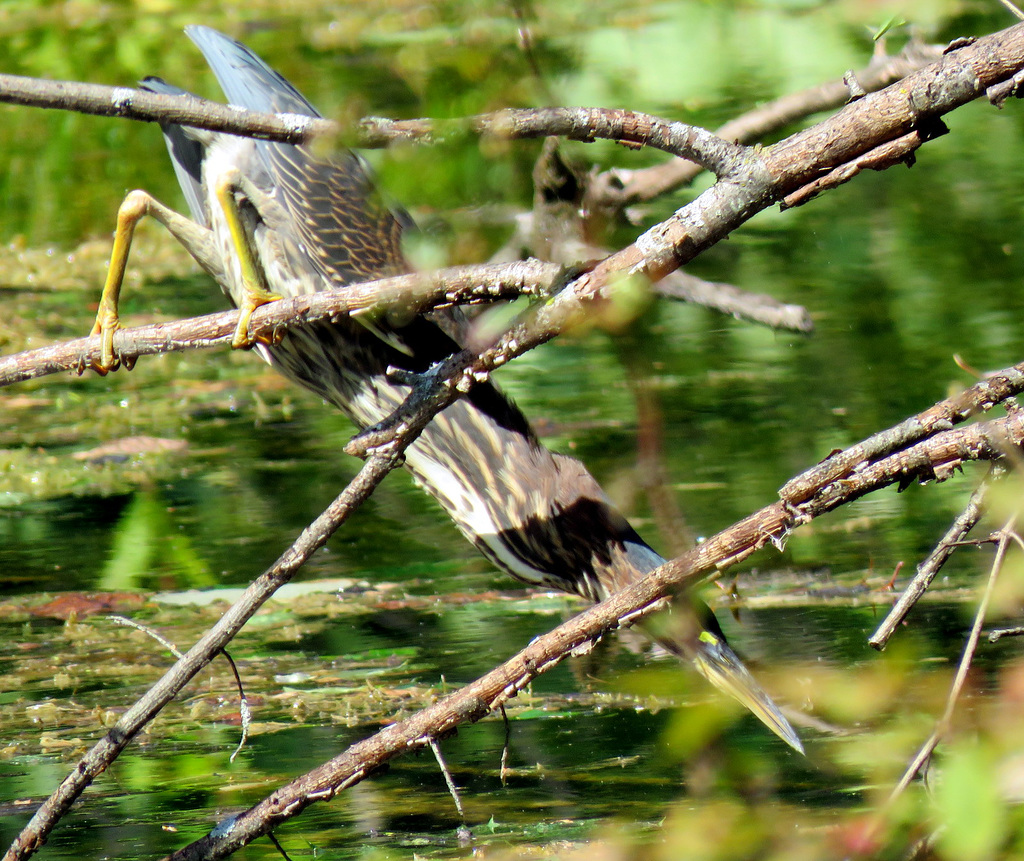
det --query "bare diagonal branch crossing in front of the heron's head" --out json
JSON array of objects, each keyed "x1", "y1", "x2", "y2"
[{"x1": 159, "y1": 403, "x2": 1024, "y2": 861}]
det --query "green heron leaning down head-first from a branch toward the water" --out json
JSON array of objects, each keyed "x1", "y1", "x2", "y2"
[{"x1": 95, "y1": 27, "x2": 803, "y2": 750}]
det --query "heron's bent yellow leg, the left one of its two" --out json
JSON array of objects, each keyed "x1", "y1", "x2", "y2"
[{"x1": 89, "y1": 189, "x2": 219, "y2": 375}]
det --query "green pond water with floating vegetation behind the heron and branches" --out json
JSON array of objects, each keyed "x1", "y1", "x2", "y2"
[{"x1": 0, "y1": 0, "x2": 1024, "y2": 859}]
